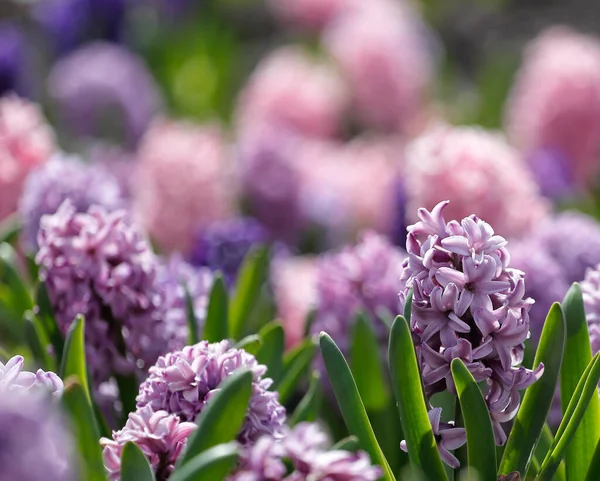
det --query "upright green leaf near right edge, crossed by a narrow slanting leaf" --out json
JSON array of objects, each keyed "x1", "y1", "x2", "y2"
[{"x1": 560, "y1": 283, "x2": 600, "y2": 480}]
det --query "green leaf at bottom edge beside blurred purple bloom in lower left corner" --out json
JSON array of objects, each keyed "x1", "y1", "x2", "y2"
[{"x1": 62, "y1": 377, "x2": 106, "y2": 481}]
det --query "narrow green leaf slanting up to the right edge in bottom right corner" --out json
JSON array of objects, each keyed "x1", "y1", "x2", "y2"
[{"x1": 536, "y1": 353, "x2": 600, "y2": 480}]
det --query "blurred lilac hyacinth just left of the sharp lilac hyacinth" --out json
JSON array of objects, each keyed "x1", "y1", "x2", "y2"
[{"x1": 311, "y1": 232, "x2": 406, "y2": 358}]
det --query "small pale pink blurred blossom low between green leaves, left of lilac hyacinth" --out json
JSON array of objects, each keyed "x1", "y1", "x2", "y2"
[{"x1": 271, "y1": 257, "x2": 317, "y2": 348}]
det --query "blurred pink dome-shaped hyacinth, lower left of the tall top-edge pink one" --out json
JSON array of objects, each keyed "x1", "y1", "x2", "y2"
[{"x1": 237, "y1": 47, "x2": 347, "y2": 137}]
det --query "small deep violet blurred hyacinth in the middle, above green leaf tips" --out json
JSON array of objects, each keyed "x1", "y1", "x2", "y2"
[{"x1": 190, "y1": 218, "x2": 268, "y2": 285}]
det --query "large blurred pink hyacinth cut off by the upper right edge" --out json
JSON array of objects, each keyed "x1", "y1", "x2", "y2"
[{"x1": 506, "y1": 27, "x2": 600, "y2": 185}]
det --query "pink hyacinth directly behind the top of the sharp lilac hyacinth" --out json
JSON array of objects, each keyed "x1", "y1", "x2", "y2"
[{"x1": 405, "y1": 125, "x2": 549, "y2": 237}]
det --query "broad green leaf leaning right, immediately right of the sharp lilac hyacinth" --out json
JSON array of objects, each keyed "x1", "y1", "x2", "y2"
[{"x1": 499, "y1": 302, "x2": 567, "y2": 475}]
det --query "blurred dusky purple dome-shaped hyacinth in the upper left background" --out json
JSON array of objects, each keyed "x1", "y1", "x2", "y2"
[{"x1": 48, "y1": 42, "x2": 161, "y2": 149}]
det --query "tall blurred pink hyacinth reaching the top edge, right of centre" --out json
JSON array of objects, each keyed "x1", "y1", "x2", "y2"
[{"x1": 325, "y1": 0, "x2": 432, "y2": 133}]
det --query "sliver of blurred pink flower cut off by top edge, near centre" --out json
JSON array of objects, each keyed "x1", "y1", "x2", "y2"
[{"x1": 269, "y1": 0, "x2": 357, "y2": 31}]
